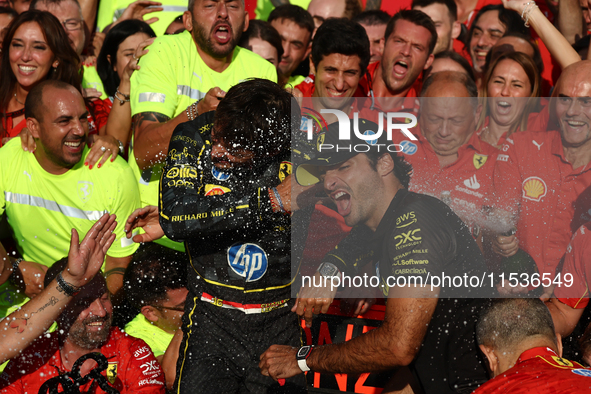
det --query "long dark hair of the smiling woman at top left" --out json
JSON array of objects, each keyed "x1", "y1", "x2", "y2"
[{"x1": 0, "y1": 10, "x2": 82, "y2": 123}]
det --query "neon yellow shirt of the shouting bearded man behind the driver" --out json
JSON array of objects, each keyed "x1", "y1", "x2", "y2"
[{"x1": 129, "y1": 31, "x2": 277, "y2": 250}]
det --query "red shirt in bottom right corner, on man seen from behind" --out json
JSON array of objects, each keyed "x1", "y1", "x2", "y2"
[{"x1": 473, "y1": 347, "x2": 591, "y2": 394}]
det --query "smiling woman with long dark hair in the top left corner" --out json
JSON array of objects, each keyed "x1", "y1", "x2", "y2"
[{"x1": 0, "y1": 11, "x2": 81, "y2": 144}]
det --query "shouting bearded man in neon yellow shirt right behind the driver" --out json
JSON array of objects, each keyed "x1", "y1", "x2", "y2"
[{"x1": 129, "y1": 0, "x2": 277, "y2": 251}]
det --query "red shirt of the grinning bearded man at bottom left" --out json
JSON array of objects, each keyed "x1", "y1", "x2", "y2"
[{"x1": 0, "y1": 328, "x2": 165, "y2": 394}]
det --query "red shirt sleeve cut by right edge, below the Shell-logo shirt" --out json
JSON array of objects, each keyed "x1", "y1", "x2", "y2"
[{"x1": 554, "y1": 222, "x2": 591, "y2": 309}]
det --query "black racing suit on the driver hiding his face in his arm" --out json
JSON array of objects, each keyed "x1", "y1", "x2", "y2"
[{"x1": 159, "y1": 112, "x2": 305, "y2": 393}]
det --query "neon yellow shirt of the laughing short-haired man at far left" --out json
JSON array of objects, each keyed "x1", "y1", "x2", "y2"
[{"x1": 0, "y1": 138, "x2": 140, "y2": 316}]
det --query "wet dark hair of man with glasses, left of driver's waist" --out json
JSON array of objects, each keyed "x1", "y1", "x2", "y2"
[{"x1": 123, "y1": 243, "x2": 190, "y2": 309}]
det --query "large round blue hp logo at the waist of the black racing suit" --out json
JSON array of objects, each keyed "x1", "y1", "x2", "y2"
[{"x1": 228, "y1": 243, "x2": 269, "y2": 282}]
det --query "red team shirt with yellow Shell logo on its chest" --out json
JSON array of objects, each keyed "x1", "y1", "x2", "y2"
[{"x1": 489, "y1": 131, "x2": 591, "y2": 275}]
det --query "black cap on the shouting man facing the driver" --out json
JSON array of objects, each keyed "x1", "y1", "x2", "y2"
[{"x1": 295, "y1": 119, "x2": 395, "y2": 186}]
